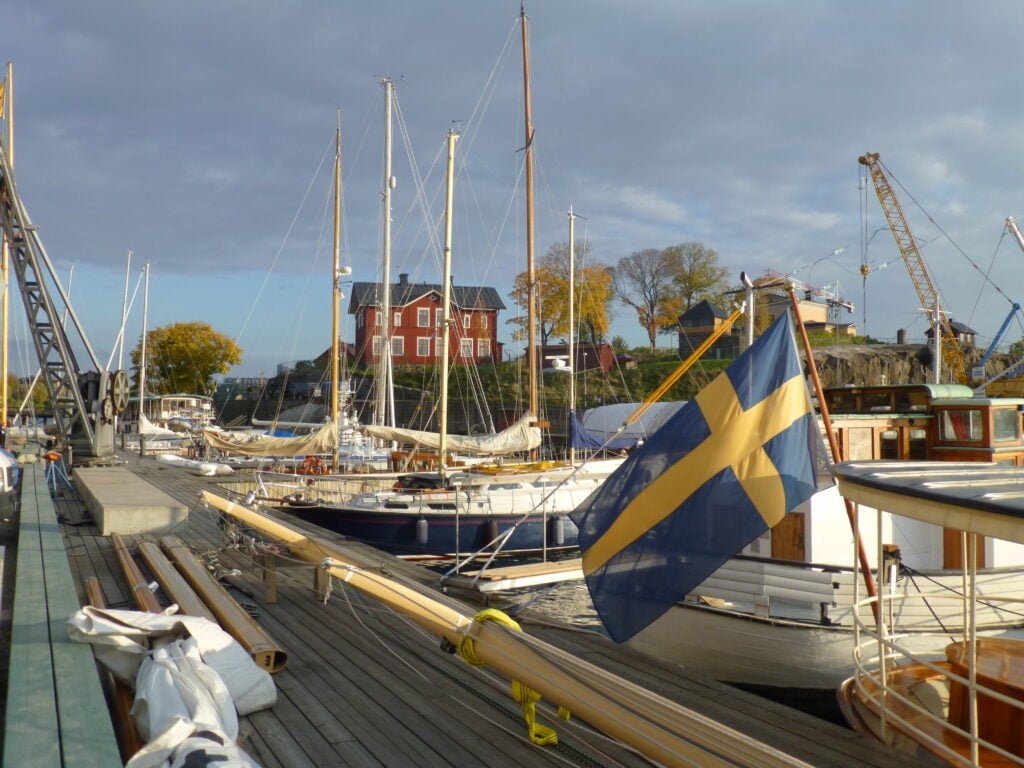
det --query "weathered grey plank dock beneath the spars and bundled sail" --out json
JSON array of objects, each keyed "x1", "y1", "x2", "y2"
[{"x1": 4, "y1": 455, "x2": 929, "y2": 768}]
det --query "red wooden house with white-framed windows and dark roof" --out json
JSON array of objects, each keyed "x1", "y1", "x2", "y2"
[{"x1": 348, "y1": 273, "x2": 505, "y2": 366}]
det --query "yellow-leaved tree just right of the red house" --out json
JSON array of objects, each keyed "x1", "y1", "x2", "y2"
[{"x1": 508, "y1": 241, "x2": 613, "y2": 345}]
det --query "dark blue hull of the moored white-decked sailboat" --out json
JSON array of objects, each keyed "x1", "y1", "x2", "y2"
[{"x1": 283, "y1": 504, "x2": 579, "y2": 555}]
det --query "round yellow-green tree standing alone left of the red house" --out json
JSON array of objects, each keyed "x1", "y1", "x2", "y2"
[{"x1": 131, "y1": 323, "x2": 242, "y2": 394}]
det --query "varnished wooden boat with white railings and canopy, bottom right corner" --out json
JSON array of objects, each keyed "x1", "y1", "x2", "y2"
[{"x1": 837, "y1": 462, "x2": 1024, "y2": 766}]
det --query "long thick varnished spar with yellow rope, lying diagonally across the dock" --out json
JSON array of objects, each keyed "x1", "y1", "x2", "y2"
[{"x1": 200, "y1": 490, "x2": 807, "y2": 768}]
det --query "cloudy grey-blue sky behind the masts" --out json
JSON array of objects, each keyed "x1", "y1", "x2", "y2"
[{"x1": 0, "y1": 0, "x2": 1024, "y2": 376}]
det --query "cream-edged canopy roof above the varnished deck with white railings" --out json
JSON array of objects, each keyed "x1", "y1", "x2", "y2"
[{"x1": 836, "y1": 461, "x2": 1024, "y2": 544}]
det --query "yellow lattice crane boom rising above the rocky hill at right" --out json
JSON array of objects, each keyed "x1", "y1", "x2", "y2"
[{"x1": 857, "y1": 153, "x2": 971, "y2": 384}]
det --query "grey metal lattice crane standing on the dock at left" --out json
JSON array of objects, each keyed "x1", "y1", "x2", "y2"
[{"x1": 0, "y1": 132, "x2": 129, "y2": 463}]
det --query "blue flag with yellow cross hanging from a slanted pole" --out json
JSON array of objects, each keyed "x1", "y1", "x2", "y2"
[{"x1": 571, "y1": 313, "x2": 830, "y2": 642}]
